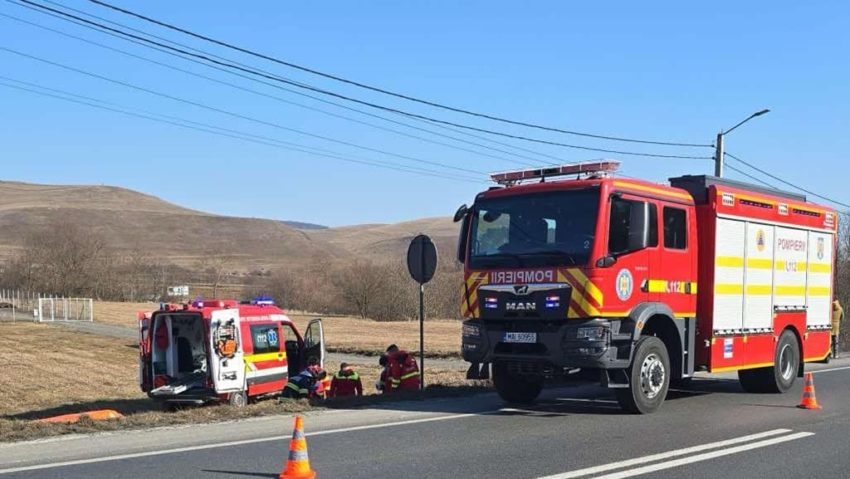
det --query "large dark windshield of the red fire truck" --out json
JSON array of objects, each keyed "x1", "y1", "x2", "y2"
[{"x1": 469, "y1": 188, "x2": 599, "y2": 269}]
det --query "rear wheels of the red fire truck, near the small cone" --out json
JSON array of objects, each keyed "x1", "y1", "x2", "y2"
[{"x1": 738, "y1": 331, "x2": 800, "y2": 393}]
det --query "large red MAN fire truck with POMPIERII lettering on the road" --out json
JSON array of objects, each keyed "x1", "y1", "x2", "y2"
[{"x1": 455, "y1": 161, "x2": 837, "y2": 413}]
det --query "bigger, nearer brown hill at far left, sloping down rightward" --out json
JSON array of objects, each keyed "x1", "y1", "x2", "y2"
[{"x1": 0, "y1": 182, "x2": 338, "y2": 271}]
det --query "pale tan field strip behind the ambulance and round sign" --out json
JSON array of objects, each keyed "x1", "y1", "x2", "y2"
[{"x1": 94, "y1": 301, "x2": 461, "y2": 357}]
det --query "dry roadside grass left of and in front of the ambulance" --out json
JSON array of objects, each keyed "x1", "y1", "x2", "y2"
[{"x1": 0, "y1": 320, "x2": 482, "y2": 441}]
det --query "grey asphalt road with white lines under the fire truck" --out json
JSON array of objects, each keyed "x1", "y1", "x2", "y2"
[{"x1": 0, "y1": 360, "x2": 850, "y2": 479}]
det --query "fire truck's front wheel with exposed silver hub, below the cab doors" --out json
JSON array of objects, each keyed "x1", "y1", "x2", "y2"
[{"x1": 614, "y1": 336, "x2": 670, "y2": 414}]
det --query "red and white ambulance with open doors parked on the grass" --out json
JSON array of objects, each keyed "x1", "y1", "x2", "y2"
[{"x1": 138, "y1": 297, "x2": 325, "y2": 408}]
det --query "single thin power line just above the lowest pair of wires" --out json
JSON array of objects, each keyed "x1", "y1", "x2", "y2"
[{"x1": 0, "y1": 46, "x2": 490, "y2": 175}]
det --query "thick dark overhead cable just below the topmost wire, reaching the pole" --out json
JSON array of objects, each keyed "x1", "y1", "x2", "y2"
[{"x1": 14, "y1": 0, "x2": 712, "y2": 159}]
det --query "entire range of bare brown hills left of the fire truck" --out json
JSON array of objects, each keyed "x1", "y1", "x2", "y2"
[{"x1": 0, "y1": 181, "x2": 458, "y2": 271}]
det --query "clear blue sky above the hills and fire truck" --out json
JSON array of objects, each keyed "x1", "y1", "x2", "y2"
[{"x1": 0, "y1": 0, "x2": 850, "y2": 225}]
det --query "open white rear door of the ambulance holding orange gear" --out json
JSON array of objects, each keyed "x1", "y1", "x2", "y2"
[{"x1": 210, "y1": 309, "x2": 245, "y2": 393}]
